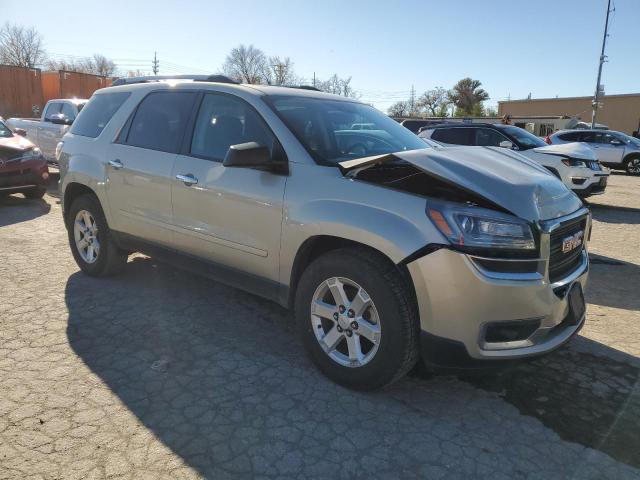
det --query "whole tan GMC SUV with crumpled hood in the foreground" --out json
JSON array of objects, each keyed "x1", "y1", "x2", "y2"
[{"x1": 59, "y1": 77, "x2": 591, "y2": 388}]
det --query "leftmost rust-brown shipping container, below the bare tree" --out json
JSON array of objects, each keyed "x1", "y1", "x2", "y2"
[{"x1": 0, "y1": 65, "x2": 45, "y2": 119}]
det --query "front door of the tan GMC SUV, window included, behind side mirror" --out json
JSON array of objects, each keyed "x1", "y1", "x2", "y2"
[{"x1": 172, "y1": 92, "x2": 287, "y2": 288}]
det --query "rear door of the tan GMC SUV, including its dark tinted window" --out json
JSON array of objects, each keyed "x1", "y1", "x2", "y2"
[{"x1": 107, "y1": 90, "x2": 197, "y2": 245}]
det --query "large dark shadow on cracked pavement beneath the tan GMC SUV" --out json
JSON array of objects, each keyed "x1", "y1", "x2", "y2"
[{"x1": 65, "y1": 257, "x2": 640, "y2": 478}]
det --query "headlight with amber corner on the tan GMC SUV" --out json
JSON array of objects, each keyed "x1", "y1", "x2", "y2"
[{"x1": 427, "y1": 202, "x2": 536, "y2": 251}]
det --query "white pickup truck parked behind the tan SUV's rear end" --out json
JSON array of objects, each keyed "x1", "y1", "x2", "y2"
[{"x1": 7, "y1": 98, "x2": 88, "y2": 163}]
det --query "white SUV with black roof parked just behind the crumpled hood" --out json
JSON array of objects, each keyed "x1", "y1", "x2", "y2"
[{"x1": 419, "y1": 123, "x2": 609, "y2": 198}]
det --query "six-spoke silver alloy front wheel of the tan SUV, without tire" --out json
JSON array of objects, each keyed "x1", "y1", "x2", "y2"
[{"x1": 311, "y1": 277, "x2": 382, "y2": 368}]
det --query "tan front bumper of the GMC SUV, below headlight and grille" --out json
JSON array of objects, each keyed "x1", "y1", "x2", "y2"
[{"x1": 407, "y1": 209, "x2": 589, "y2": 366}]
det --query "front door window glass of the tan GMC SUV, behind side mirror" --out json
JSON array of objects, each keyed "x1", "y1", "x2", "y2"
[{"x1": 191, "y1": 93, "x2": 276, "y2": 162}]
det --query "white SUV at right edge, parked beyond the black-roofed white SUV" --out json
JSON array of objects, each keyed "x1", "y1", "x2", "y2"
[{"x1": 545, "y1": 130, "x2": 640, "y2": 175}]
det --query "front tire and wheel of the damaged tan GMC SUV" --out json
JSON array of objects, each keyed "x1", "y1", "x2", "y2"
[{"x1": 295, "y1": 248, "x2": 419, "y2": 390}]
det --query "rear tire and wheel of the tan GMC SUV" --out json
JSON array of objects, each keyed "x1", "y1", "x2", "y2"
[{"x1": 66, "y1": 194, "x2": 128, "y2": 277}]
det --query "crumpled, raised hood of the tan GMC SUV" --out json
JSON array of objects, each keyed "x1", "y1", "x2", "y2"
[{"x1": 340, "y1": 147, "x2": 582, "y2": 222}]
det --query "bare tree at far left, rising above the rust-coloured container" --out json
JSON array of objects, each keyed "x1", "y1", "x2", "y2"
[{"x1": 0, "y1": 22, "x2": 45, "y2": 68}]
